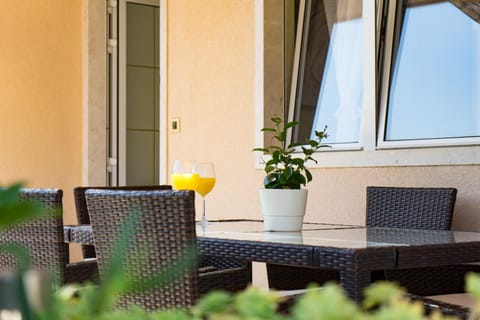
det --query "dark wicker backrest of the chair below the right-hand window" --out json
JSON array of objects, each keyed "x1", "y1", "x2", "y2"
[{"x1": 367, "y1": 187, "x2": 457, "y2": 230}]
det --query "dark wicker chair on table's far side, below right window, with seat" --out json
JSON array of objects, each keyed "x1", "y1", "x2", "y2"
[{"x1": 267, "y1": 187, "x2": 458, "y2": 295}]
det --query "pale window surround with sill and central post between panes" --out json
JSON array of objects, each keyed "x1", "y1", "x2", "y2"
[{"x1": 254, "y1": 0, "x2": 480, "y2": 169}]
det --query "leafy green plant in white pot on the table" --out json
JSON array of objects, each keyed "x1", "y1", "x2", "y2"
[{"x1": 253, "y1": 117, "x2": 329, "y2": 232}]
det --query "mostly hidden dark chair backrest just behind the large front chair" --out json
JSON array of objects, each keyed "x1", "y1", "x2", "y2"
[{"x1": 73, "y1": 185, "x2": 172, "y2": 258}]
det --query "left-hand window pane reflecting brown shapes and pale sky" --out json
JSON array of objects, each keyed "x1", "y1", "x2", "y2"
[{"x1": 291, "y1": 0, "x2": 363, "y2": 144}]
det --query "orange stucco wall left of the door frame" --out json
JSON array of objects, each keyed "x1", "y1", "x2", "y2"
[{"x1": 0, "y1": 0, "x2": 82, "y2": 236}]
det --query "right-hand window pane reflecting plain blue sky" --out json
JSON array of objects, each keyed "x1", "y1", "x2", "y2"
[{"x1": 385, "y1": 0, "x2": 480, "y2": 140}]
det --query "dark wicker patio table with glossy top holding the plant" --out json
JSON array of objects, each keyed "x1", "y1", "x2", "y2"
[{"x1": 64, "y1": 220, "x2": 480, "y2": 300}]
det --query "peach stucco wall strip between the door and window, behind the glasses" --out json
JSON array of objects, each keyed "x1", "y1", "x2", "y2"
[{"x1": 167, "y1": 0, "x2": 259, "y2": 218}]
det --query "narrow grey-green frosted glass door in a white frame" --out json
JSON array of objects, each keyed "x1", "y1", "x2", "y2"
[{"x1": 119, "y1": 1, "x2": 159, "y2": 185}]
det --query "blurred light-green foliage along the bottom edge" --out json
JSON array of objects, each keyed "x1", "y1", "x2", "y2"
[{"x1": 40, "y1": 274, "x2": 480, "y2": 320}]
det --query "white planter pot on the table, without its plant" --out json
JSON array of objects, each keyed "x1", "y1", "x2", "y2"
[{"x1": 260, "y1": 189, "x2": 308, "y2": 232}]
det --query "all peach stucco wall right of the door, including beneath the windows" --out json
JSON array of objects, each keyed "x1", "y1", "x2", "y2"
[{"x1": 168, "y1": 0, "x2": 480, "y2": 230}]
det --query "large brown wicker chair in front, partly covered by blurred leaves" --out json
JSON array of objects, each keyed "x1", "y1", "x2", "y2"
[{"x1": 85, "y1": 190, "x2": 251, "y2": 310}]
